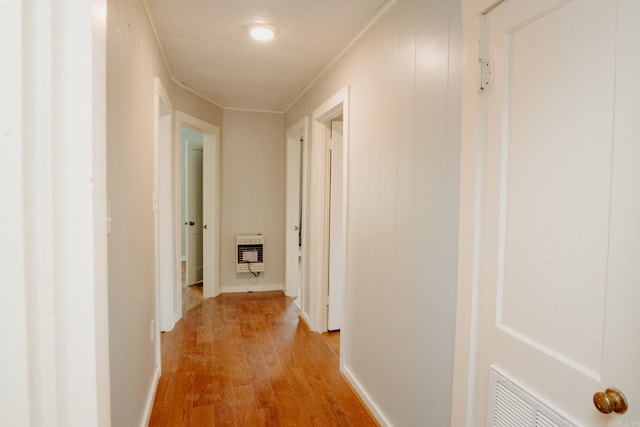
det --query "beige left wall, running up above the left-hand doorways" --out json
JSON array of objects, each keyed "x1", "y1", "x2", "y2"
[{"x1": 107, "y1": 0, "x2": 222, "y2": 426}]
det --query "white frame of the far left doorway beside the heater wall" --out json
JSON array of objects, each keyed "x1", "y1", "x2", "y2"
[{"x1": 173, "y1": 110, "x2": 220, "y2": 302}]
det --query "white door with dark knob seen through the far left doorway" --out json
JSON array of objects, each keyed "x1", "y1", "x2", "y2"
[{"x1": 186, "y1": 142, "x2": 203, "y2": 285}]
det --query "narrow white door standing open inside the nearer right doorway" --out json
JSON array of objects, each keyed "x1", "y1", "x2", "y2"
[{"x1": 327, "y1": 121, "x2": 345, "y2": 331}]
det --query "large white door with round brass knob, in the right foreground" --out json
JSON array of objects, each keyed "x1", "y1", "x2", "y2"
[{"x1": 471, "y1": 0, "x2": 640, "y2": 427}]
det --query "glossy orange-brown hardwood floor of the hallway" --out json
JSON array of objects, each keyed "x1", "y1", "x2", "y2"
[{"x1": 149, "y1": 292, "x2": 378, "y2": 427}]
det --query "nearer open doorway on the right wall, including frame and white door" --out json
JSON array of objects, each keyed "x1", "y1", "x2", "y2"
[{"x1": 309, "y1": 88, "x2": 349, "y2": 348}]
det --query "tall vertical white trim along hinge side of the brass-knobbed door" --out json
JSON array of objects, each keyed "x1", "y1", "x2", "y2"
[{"x1": 451, "y1": 11, "x2": 484, "y2": 427}]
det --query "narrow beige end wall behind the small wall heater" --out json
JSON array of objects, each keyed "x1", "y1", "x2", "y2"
[{"x1": 220, "y1": 110, "x2": 286, "y2": 292}]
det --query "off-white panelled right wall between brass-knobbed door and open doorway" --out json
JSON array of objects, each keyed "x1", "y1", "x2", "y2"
[{"x1": 286, "y1": 0, "x2": 461, "y2": 426}]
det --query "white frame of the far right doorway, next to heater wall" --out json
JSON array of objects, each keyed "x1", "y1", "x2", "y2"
[{"x1": 285, "y1": 117, "x2": 309, "y2": 302}]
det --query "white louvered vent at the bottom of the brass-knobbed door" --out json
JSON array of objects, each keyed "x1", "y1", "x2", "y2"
[{"x1": 487, "y1": 367, "x2": 575, "y2": 427}]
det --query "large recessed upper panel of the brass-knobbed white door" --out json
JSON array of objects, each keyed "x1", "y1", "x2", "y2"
[{"x1": 488, "y1": 1, "x2": 615, "y2": 374}]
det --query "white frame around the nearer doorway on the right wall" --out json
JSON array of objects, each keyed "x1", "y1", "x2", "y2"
[{"x1": 303, "y1": 86, "x2": 349, "y2": 338}]
